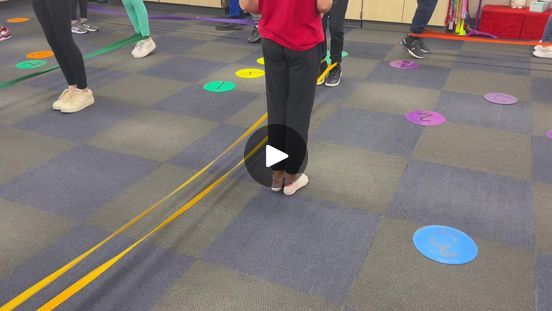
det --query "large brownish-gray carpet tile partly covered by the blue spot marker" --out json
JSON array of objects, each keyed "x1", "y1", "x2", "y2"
[{"x1": 347, "y1": 217, "x2": 535, "y2": 311}]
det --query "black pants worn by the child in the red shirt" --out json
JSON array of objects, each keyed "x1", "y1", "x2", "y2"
[{"x1": 263, "y1": 39, "x2": 321, "y2": 174}]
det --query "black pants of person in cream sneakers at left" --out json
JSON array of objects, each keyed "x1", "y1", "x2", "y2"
[{"x1": 33, "y1": 0, "x2": 87, "y2": 89}]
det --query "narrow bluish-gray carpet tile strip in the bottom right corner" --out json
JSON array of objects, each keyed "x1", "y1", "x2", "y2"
[{"x1": 536, "y1": 253, "x2": 552, "y2": 311}]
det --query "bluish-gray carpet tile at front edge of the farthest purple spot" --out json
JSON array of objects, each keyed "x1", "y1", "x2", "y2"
[{"x1": 368, "y1": 62, "x2": 450, "y2": 89}]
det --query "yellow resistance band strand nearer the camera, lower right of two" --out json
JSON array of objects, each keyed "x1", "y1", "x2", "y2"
[{"x1": 38, "y1": 136, "x2": 268, "y2": 311}]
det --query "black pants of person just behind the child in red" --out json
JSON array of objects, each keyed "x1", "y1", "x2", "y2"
[{"x1": 322, "y1": 0, "x2": 349, "y2": 63}]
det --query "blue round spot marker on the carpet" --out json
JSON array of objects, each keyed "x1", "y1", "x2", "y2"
[{"x1": 412, "y1": 226, "x2": 479, "y2": 265}]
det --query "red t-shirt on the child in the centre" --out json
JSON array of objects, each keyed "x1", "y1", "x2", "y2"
[{"x1": 259, "y1": 0, "x2": 324, "y2": 51}]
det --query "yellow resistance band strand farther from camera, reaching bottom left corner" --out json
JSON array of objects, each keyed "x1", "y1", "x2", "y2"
[{"x1": 0, "y1": 113, "x2": 268, "y2": 311}]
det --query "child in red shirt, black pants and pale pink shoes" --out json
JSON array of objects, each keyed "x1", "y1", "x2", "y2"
[{"x1": 240, "y1": 0, "x2": 333, "y2": 195}]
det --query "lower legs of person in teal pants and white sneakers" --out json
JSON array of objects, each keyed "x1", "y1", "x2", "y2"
[{"x1": 123, "y1": 0, "x2": 156, "y2": 58}]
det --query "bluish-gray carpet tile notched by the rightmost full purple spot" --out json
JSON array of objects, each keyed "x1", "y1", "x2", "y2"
[{"x1": 434, "y1": 91, "x2": 532, "y2": 134}]
